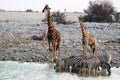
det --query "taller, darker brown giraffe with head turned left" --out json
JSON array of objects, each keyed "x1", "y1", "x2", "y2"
[{"x1": 42, "y1": 5, "x2": 61, "y2": 53}]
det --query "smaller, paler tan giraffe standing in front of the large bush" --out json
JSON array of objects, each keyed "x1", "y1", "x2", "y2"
[{"x1": 79, "y1": 16, "x2": 98, "y2": 56}]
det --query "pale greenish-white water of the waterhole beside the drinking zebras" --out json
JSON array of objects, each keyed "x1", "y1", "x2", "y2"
[{"x1": 0, "y1": 61, "x2": 120, "y2": 80}]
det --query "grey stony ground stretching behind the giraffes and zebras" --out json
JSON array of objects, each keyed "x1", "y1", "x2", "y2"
[{"x1": 0, "y1": 13, "x2": 120, "y2": 67}]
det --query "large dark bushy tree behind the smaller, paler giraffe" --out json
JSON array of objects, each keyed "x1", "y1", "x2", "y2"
[{"x1": 84, "y1": 0, "x2": 116, "y2": 22}]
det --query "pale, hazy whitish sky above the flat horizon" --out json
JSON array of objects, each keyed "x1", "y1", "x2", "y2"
[{"x1": 0, "y1": 0, "x2": 120, "y2": 12}]
